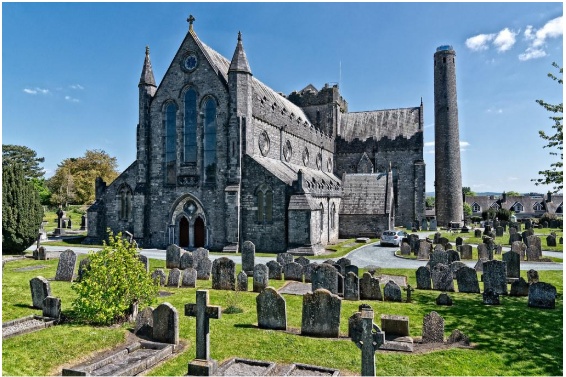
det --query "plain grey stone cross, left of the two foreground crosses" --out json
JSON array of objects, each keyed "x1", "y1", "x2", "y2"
[{"x1": 185, "y1": 289, "x2": 222, "y2": 376}]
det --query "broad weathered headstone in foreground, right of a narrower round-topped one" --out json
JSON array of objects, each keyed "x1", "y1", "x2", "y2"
[{"x1": 301, "y1": 289, "x2": 342, "y2": 338}]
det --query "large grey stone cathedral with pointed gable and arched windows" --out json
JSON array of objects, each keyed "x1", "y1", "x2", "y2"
[{"x1": 86, "y1": 16, "x2": 425, "y2": 255}]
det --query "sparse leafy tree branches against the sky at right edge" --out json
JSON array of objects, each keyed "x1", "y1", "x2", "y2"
[{"x1": 531, "y1": 63, "x2": 564, "y2": 192}]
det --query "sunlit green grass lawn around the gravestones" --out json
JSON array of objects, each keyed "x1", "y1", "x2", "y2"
[{"x1": 2, "y1": 254, "x2": 563, "y2": 376}]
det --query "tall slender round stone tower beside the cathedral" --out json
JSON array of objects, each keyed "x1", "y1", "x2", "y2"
[{"x1": 434, "y1": 46, "x2": 464, "y2": 226}]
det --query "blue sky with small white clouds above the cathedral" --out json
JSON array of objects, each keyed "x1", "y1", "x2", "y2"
[{"x1": 2, "y1": 2, "x2": 563, "y2": 192}]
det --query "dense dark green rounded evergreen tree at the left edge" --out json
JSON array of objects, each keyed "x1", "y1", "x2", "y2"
[{"x1": 2, "y1": 164, "x2": 43, "y2": 254}]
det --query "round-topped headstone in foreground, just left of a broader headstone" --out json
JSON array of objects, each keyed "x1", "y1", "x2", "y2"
[{"x1": 256, "y1": 287, "x2": 287, "y2": 330}]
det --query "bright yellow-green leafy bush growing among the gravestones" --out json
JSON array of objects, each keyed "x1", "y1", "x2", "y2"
[{"x1": 72, "y1": 233, "x2": 157, "y2": 325}]
